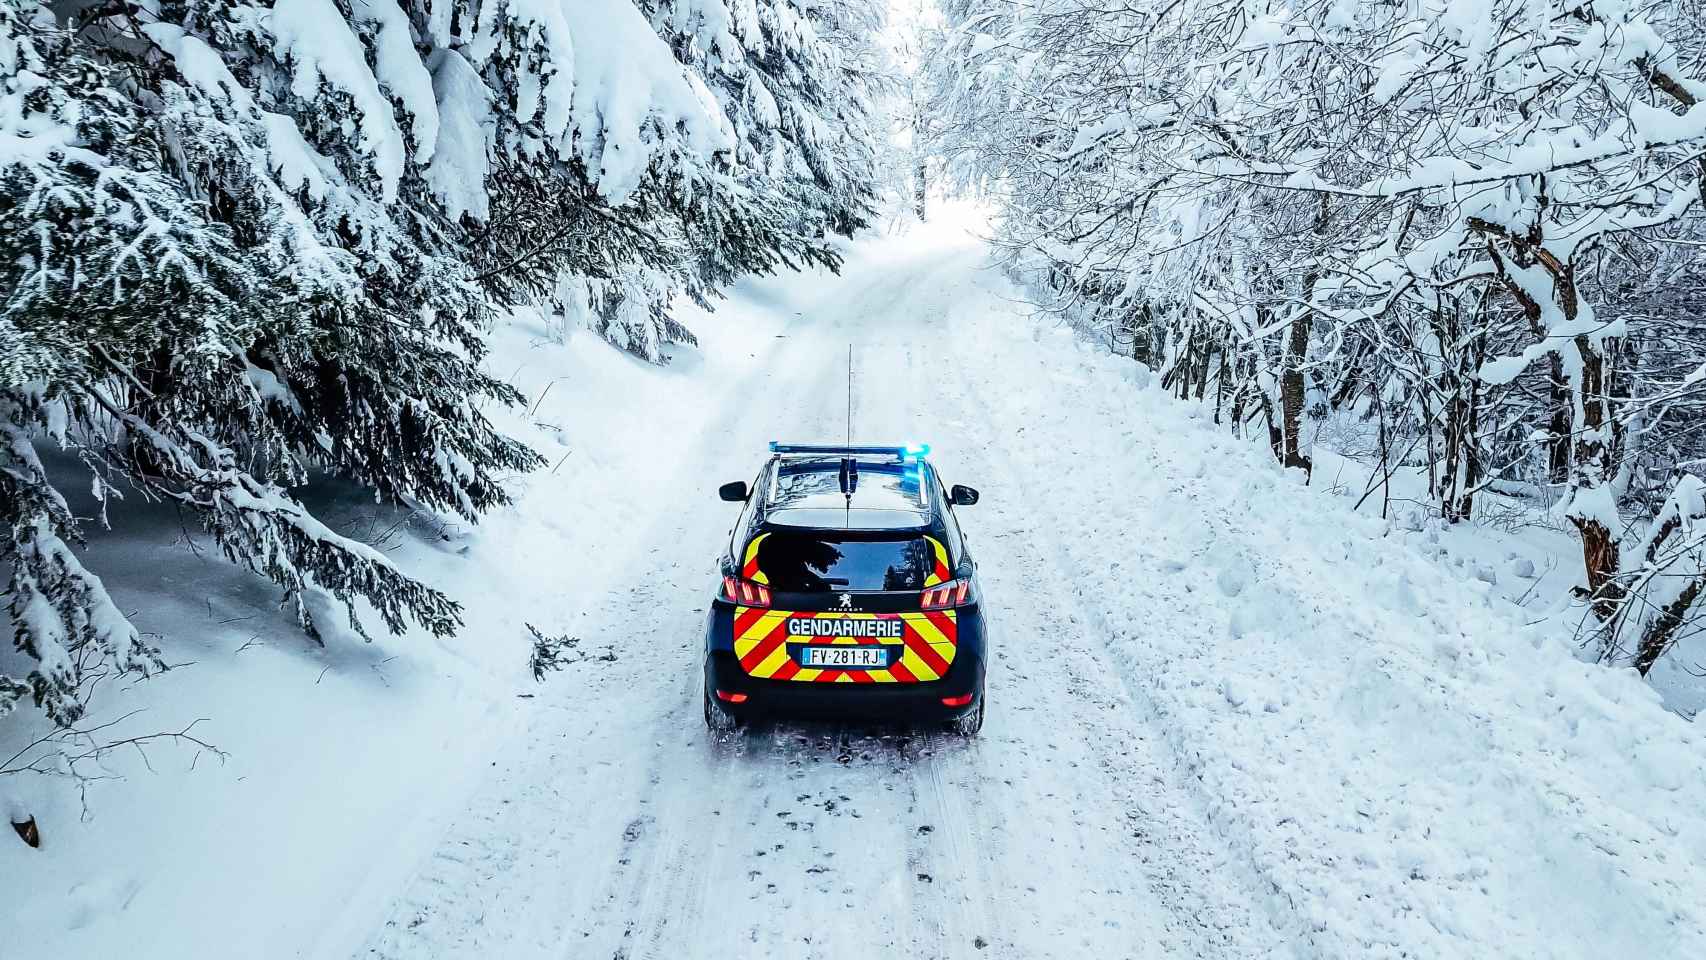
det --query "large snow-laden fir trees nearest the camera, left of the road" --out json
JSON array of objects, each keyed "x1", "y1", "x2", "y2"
[{"x1": 0, "y1": 0, "x2": 754, "y2": 725}]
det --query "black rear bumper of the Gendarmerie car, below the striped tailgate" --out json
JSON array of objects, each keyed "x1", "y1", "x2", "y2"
[{"x1": 705, "y1": 648, "x2": 984, "y2": 720}]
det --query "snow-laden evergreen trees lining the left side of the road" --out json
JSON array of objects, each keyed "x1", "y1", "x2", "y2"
[{"x1": 0, "y1": 0, "x2": 885, "y2": 726}]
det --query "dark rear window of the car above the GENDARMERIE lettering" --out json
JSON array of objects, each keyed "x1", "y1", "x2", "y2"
[{"x1": 757, "y1": 530, "x2": 931, "y2": 593}]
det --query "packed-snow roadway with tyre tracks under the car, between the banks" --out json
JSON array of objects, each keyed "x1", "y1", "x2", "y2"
[{"x1": 368, "y1": 230, "x2": 1278, "y2": 960}]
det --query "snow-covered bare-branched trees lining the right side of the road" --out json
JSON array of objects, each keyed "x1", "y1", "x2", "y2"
[{"x1": 921, "y1": 0, "x2": 1706, "y2": 682}]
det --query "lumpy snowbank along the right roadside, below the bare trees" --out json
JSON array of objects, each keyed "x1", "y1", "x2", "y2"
[{"x1": 962, "y1": 298, "x2": 1706, "y2": 957}]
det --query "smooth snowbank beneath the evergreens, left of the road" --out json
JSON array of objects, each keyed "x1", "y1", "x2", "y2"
[{"x1": 0, "y1": 300, "x2": 784, "y2": 960}]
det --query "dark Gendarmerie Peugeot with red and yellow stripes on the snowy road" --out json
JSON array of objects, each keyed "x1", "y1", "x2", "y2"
[{"x1": 705, "y1": 443, "x2": 984, "y2": 737}]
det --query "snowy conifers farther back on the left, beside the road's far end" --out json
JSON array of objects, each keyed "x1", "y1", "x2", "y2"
[{"x1": 536, "y1": 0, "x2": 887, "y2": 361}]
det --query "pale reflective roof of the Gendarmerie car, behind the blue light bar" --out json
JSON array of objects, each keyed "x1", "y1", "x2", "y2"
[{"x1": 764, "y1": 455, "x2": 935, "y2": 530}]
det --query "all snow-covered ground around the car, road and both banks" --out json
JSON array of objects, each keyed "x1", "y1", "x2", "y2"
[{"x1": 0, "y1": 206, "x2": 1706, "y2": 960}]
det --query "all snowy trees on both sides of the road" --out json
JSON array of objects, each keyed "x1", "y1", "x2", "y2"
[{"x1": 13, "y1": 0, "x2": 1706, "y2": 740}]
